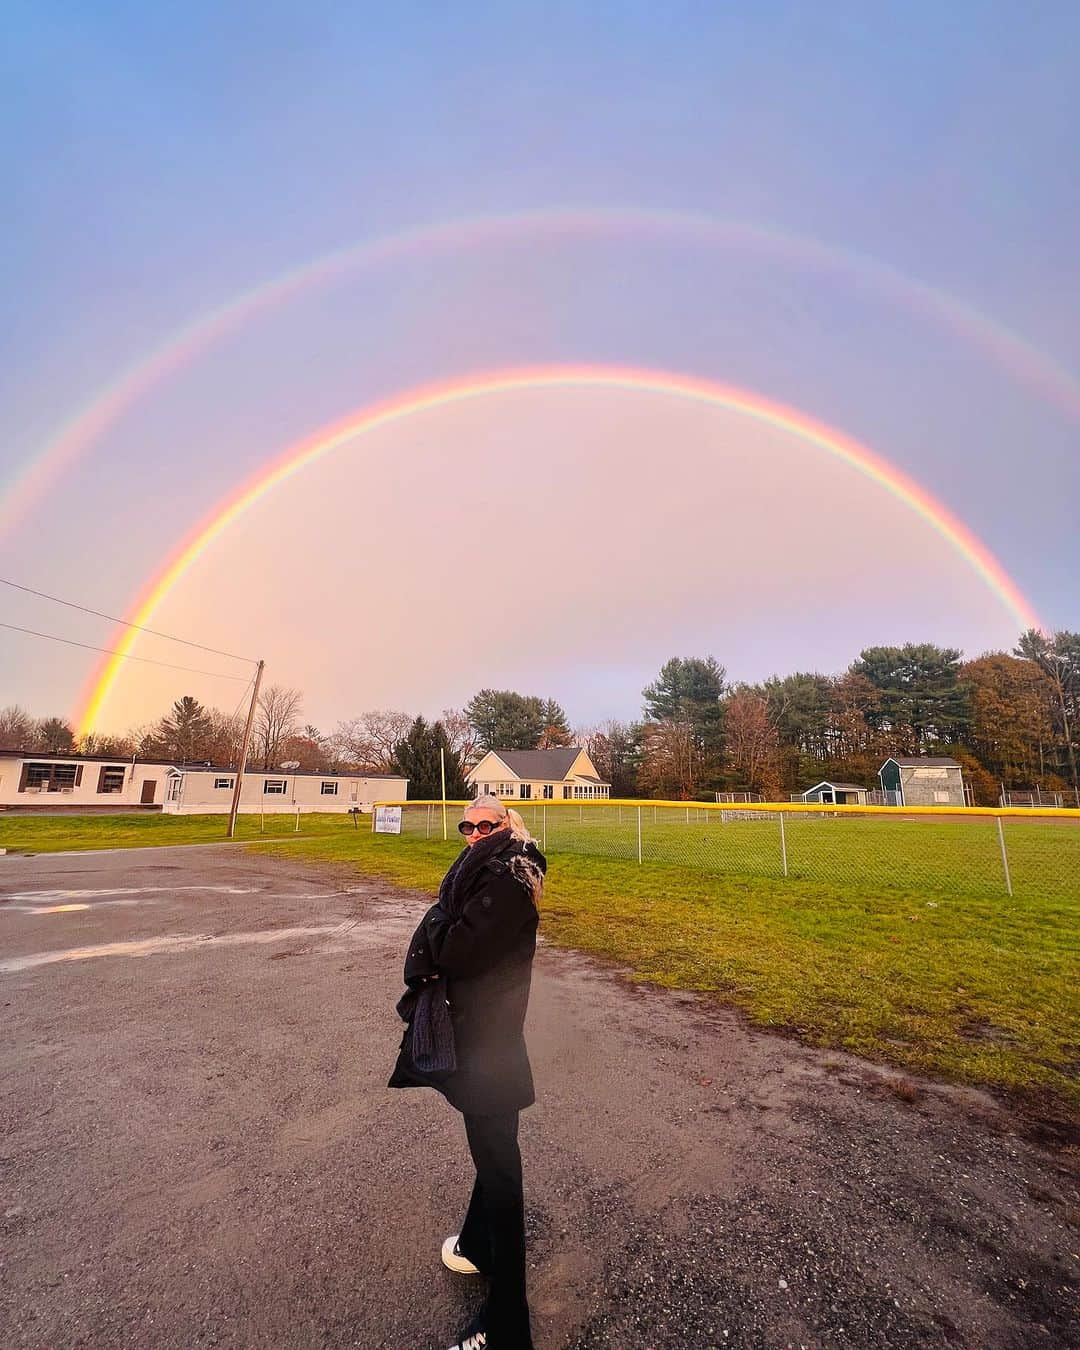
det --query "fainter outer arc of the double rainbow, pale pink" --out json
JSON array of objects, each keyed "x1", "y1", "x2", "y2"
[{"x1": 8, "y1": 207, "x2": 1080, "y2": 536}]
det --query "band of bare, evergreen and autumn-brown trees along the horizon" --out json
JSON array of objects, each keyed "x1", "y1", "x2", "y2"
[{"x1": 0, "y1": 629, "x2": 1080, "y2": 805}]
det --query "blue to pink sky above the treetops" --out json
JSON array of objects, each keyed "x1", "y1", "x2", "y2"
[{"x1": 0, "y1": 0, "x2": 1080, "y2": 730}]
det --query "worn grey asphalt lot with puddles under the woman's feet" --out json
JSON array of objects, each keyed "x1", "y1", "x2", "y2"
[{"x1": 0, "y1": 848, "x2": 1080, "y2": 1350}]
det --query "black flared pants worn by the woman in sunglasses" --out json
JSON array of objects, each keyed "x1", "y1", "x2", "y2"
[{"x1": 458, "y1": 1111, "x2": 532, "y2": 1350}]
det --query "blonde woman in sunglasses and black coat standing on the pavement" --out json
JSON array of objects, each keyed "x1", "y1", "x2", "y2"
[{"x1": 389, "y1": 797, "x2": 547, "y2": 1350}]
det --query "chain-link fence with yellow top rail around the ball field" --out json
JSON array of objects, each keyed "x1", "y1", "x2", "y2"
[{"x1": 373, "y1": 802, "x2": 1080, "y2": 900}]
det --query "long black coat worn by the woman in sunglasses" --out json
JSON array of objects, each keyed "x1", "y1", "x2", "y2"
[{"x1": 389, "y1": 840, "x2": 547, "y2": 1115}]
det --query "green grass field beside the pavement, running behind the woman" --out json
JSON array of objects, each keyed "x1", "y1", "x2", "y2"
[{"x1": 0, "y1": 813, "x2": 1080, "y2": 1119}]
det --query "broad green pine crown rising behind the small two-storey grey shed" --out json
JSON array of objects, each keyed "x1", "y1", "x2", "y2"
[{"x1": 851, "y1": 643, "x2": 971, "y2": 755}]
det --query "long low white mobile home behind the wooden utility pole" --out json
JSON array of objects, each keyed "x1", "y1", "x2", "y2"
[{"x1": 162, "y1": 765, "x2": 409, "y2": 815}]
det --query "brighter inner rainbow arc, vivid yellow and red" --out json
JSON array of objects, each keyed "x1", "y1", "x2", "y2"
[{"x1": 73, "y1": 366, "x2": 1040, "y2": 734}]
